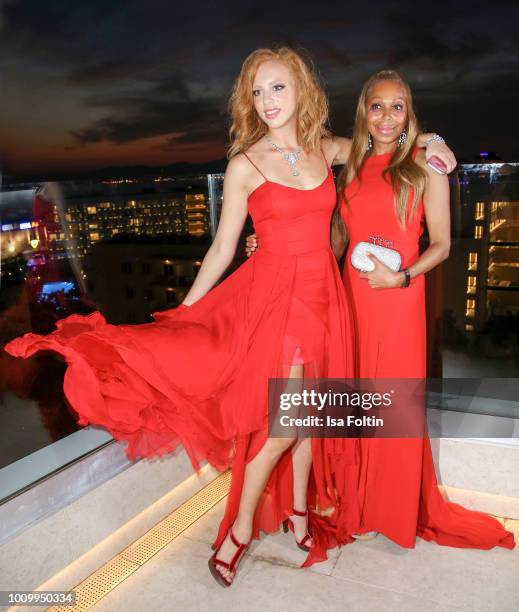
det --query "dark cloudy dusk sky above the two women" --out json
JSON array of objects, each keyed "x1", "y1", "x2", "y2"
[{"x1": 0, "y1": 0, "x2": 519, "y2": 175}]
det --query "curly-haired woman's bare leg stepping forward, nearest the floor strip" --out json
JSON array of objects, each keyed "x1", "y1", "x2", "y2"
[{"x1": 217, "y1": 365, "x2": 308, "y2": 579}]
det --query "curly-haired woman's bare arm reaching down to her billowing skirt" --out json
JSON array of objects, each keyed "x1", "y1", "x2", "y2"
[{"x1": 183, "y1": 156, "x2": 248, "y2": 306}]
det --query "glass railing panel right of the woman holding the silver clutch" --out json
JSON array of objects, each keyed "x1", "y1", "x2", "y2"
[{"x1": 440, "y1": 163, "x2": 519, "y2": 378}]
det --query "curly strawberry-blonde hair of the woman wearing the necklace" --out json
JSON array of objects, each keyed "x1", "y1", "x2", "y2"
[{"x1": 227, "y1": 47, "x2": 330, "y2": 158}]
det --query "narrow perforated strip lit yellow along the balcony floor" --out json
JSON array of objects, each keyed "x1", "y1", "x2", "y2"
[{"x1": 47, "y1": 470, "x2": 231, "y2": 612}]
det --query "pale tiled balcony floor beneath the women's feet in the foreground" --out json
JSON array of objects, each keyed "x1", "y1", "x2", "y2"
[{"x1": 92, "y1": 501, "x2": 519, "y2": 612}]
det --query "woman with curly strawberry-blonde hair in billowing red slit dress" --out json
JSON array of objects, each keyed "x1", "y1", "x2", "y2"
[{"x1": 6, "y1": 49, "x2": 362, "y2": 586}]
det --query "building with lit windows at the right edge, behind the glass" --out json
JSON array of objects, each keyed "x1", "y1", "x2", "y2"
[{"x1": 444, "y1": 163, "x2": 519, "y2": 335}]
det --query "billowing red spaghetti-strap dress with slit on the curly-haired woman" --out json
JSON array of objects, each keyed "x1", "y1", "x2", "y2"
[{"x1": 6, "y1": 161, "x2": 362, "y2": 565}]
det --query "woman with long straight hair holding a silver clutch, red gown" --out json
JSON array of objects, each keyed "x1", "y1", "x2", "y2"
[{"x1": 339, "y1": 71, "x2": 514, "y2": 549}]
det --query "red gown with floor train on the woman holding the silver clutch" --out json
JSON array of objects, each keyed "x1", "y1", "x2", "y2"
[{"x1": 341, "y1": 154, "x2": 514, "y2": 549}]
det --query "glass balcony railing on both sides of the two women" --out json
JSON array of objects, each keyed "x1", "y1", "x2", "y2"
[{"x1": 0, "y1": 164, "x2": 519, "y2": 499}]
